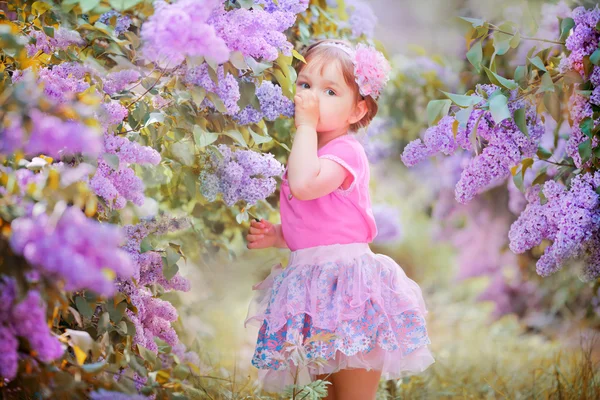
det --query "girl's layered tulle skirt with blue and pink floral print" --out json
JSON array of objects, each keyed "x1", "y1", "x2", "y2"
[{"x1": 244, "y1": 243, "x2": 435, "y2": 392}]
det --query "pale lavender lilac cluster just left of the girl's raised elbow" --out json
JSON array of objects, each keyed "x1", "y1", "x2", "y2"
[{"x1": 200, "y1": 144, "x2": 283, "y2": 206}]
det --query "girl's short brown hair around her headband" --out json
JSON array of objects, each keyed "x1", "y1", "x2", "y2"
[{"x1": 294, "y1": 39, "x2": 379, "y2": 131}]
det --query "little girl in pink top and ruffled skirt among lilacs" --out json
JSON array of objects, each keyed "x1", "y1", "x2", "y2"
[{"x1": 244, "y1": 40, "x2": 434, "y2": 400}]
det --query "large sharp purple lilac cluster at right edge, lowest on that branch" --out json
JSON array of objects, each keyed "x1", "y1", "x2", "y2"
[{"x1": 509, "y1": 172, "x2": 600, "y2": 276}]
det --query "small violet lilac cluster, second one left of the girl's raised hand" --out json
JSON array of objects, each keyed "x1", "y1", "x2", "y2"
[{"x1": 185, "y1": 63, "x2": 241, "y2": 115}]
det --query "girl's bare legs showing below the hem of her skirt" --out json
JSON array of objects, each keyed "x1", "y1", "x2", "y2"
[{"x1": 331, "y1": 368, "x2": 381, "y2": 400}]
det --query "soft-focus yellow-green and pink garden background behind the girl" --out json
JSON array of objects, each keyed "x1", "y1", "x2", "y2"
[{"x1": 170, "y1": 0, "x2": 600, "y2": 398}]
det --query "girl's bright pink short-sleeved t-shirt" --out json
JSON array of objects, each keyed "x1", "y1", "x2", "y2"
[{"x1": 280, "y1": 134, "x2": 377, "y2": 250}]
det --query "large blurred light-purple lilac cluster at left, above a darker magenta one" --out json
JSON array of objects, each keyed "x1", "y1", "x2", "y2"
[{"x1": 10, "y1": 207, "x2": 133, "y2": 296}]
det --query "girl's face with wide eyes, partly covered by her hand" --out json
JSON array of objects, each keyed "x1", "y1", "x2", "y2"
[{"x1": 296, "y1": 60, "x2": 366, "y2": 133}]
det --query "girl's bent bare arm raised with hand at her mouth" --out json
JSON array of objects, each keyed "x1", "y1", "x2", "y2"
[{"x1": 287, "y1": 90, "x2": 349, "y2": 200}]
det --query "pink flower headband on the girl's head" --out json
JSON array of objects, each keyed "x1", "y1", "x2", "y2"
[{"x1": 319, "y1": 42, "x2": 391, "y2": 99}]
